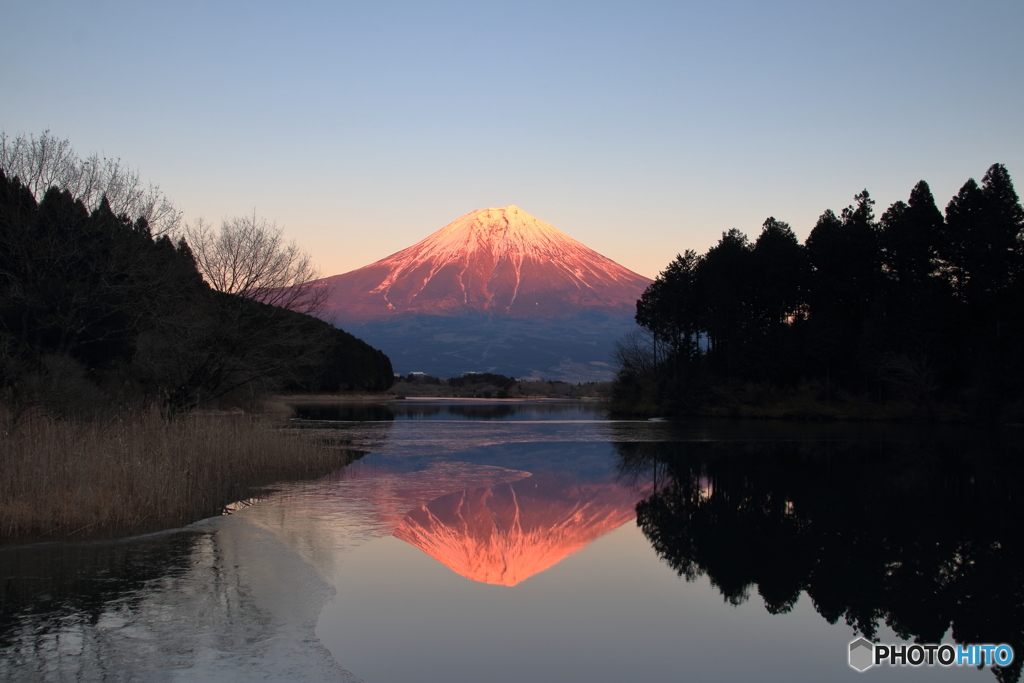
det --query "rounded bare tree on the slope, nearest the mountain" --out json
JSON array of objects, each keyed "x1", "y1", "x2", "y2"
[{"x1": 185, "y1": 211, "x2": 330, "y2": 314}]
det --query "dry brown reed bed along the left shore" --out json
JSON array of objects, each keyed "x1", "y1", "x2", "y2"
[{"x1": 0, "y1": 405, "x2": 352, "y2": 543}]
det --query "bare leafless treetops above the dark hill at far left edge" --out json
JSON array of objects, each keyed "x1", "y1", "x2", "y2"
[{"x1": 0, "y1": 130, "x2": 181, "y2": 237}]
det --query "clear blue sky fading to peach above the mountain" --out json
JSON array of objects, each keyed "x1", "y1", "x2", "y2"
[{"x1": 0, "y1": 0, "x2": 1024, "y2": 276}]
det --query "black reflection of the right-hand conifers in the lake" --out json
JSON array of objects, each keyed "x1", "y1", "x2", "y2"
[{"x1": 616, "y1": 441, "x2": 1024, "y2": 681}]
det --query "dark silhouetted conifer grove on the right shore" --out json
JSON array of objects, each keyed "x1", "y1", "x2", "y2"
[{"x1": 613, "y1": 164, "x2": 1024, "y2": 419}]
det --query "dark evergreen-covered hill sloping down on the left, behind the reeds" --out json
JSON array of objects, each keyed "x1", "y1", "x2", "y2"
[{"x1": 0, "y1": 171, "x2": 393, "y2": 414}]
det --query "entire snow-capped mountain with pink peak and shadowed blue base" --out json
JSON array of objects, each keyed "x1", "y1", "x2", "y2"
[{"x1": 316, "y1": 206, "x2": 651, "y2": 381}]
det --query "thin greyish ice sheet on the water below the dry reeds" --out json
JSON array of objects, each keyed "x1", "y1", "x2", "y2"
[{"x1": 0, "y1": 516, "x2": 360, "y2": 683}]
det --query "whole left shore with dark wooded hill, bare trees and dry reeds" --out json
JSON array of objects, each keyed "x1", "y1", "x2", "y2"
[{"x1": 0, "y1": 133, "x2": 394, "y2": 545}]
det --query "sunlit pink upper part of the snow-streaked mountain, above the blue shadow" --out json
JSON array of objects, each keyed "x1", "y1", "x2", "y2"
[{"x1": 321, "y1": 206, "x2": 651, "y2": 323}]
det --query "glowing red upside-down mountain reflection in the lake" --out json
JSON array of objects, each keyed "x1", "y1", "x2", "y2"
[{"x1": 394, "y1": 473, "x2": 638, "y2": 586}]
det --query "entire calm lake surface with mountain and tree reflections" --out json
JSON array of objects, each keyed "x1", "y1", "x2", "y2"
[{"x1": 0, "y1": 400, "x2": 1024, "y2": 683}]
